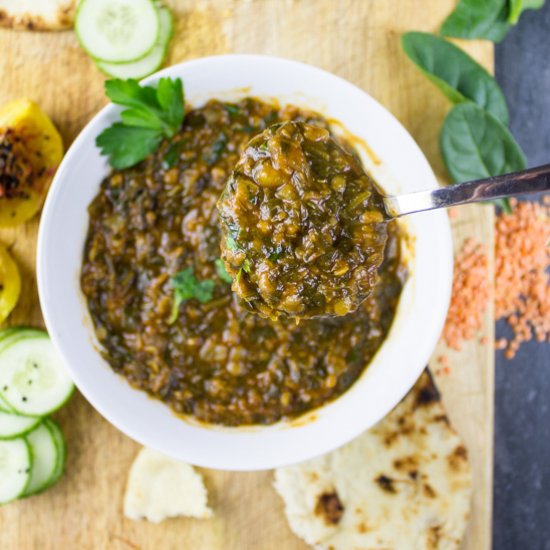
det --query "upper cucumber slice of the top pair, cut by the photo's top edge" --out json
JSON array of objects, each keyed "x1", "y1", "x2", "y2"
[{"x1": 75, "y1": 0, "x2": 160, "y2": 63}]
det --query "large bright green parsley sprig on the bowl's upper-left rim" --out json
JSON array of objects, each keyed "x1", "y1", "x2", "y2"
[{"x1": 96, "y1": 78, "x2": 185, "y2": 169}]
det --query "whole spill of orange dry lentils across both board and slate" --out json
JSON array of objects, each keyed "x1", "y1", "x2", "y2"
[{"x1": 444, "y1": 201, "x2": 550, "y2": 360}]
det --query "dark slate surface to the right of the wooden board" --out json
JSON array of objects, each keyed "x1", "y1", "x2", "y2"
[{"x1": 493, "y1": 2, "x2": 550, "y2": 550}]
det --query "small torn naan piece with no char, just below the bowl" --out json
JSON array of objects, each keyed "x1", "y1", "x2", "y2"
[{"x1": 124, "y1": 448, "x2": 213, "y2": 523}]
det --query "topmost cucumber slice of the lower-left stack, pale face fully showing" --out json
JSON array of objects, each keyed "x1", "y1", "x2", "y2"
[{"x1": 0, "y1": 333, "x2": 74, "y2": 416}]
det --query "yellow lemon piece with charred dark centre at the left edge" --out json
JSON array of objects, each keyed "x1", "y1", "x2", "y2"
[{"x1": 0, "y1": 99, "x2": 63, "y2": 226}]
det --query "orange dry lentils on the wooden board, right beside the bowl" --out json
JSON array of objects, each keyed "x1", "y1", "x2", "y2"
[{"x1": 441, "y1": 238, "x2": 490, "y2": 354}]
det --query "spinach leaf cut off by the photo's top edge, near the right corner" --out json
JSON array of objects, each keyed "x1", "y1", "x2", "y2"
[{"x1": 441, "y1": 0, "x2": 510, "y2": 42}]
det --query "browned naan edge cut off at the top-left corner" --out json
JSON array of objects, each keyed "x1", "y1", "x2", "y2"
[{"x1": 0, "y1": 0, "x2": 76, "y2": 31}]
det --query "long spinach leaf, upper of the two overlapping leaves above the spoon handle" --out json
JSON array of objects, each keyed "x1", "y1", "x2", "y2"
[{"x1": 401, "y1": 32, "x2": 509, "y2": 124}]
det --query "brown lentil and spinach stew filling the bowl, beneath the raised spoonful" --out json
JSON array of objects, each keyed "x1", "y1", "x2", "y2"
[{"x1": 81, "y1": 98, "x2": 405, "y2": 426}]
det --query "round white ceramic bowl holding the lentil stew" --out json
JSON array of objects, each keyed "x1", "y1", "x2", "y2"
[{"x1": 38, "y1": 55, "x2": 452, "y2": 470}]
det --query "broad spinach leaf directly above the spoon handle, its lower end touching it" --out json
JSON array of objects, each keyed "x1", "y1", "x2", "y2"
[{"x1": 440, "y1": 103, "x2": 527, "y2": 182}]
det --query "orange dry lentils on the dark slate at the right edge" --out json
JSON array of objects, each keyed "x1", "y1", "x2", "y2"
[{"x1": 495, "y1": 201, "x2": 550, "y2": 359}]
